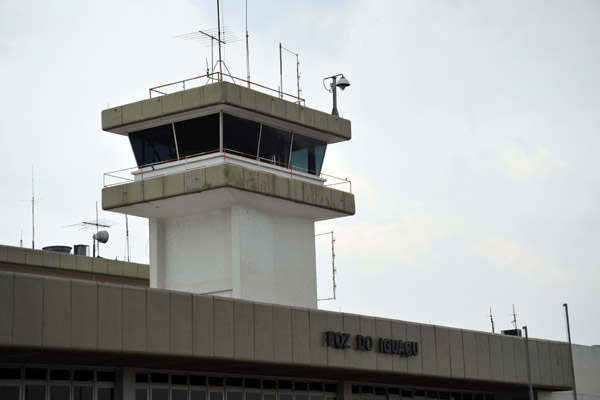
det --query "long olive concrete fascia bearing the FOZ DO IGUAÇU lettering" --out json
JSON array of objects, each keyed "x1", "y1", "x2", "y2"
[{"x1": 0, "y1": 272, "x2": 572, "y2": 390}]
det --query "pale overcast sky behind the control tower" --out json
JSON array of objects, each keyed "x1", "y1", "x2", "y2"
[{"x1": 0, "y1": 0, "x2": 600, "y2": 345}]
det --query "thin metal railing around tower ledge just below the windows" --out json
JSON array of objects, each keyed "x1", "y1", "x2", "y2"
[{"x1": 102, "y1": 148, "x2": 352, "y2": 193}]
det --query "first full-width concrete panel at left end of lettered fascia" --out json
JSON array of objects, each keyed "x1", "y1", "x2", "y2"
[{"x1": 13, "y1": 275, "x2": 44, "y2": 346}]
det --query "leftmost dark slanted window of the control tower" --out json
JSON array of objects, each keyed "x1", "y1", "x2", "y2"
[{"x1": 129, "y1": 124, "x2": 177, "y2": 166}]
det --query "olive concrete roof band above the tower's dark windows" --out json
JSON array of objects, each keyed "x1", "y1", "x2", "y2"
[{"x1": 102, "y1": 82, "x2": 352, "y2": 141}]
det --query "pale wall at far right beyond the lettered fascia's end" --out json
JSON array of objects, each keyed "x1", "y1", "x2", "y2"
[{"x1": 538, "y1": 344, "x2": 600, "y2": 400}]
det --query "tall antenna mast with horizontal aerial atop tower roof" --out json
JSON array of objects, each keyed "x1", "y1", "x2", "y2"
[{"x1": 174, "y1": 0, "x2": 238, "y2": 82}]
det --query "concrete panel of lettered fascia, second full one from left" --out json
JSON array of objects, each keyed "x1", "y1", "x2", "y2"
[{"x1": 42, "y1": 278, "x2": 71, "y2": 348}]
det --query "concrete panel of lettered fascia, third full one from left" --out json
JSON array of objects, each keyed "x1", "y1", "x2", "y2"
[{"x1": 71, "y1": 280, "x2": 98, "y2": 349}]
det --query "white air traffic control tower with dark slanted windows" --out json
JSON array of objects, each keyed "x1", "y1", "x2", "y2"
[{"x1": 102, "y1": 82, "x2": 354, "y2": 308}]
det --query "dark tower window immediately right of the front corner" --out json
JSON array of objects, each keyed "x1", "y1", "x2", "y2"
[{"x1": 223, "y1": 114, "x2": 260, "y2": 158}]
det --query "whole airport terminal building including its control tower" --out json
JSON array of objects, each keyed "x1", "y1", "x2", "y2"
[{"x1": 0, "y1": 81, "x2": 600, "y2": 400}]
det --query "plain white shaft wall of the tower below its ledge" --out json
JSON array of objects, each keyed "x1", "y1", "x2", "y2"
[{"x1": 150, "y1": 202, "x2": 317, "y2": 308}]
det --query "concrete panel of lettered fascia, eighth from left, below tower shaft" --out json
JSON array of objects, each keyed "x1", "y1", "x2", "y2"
[{"x1": 170, "y1": 292, "x2": 193, "y2": 355}]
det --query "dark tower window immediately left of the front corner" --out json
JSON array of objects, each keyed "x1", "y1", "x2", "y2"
[{"x1": 175, "y1": 114, "x2": 220, "y2": 157}]
